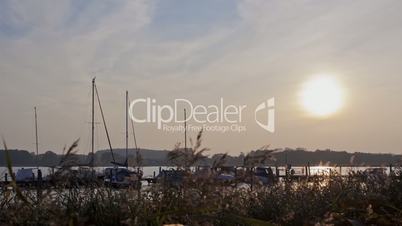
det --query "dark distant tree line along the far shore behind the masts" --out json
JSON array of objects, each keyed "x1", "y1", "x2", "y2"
[{"x1": 0, "y1": 149, "x2": 402, "y2": 166}]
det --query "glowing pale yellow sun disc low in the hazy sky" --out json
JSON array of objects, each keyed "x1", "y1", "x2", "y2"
[{"x1": 300, "y1": 76, "x2": 344, "y2": 117}]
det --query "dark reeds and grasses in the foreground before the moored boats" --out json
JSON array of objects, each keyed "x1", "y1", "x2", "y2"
[{"x1": 0, "y1": 136, "x2": 402, "y2": 226}]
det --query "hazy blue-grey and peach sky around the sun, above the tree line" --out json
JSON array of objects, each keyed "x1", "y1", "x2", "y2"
[{"x1": 0, "y1": 0, "x2": 402, "y2": 154}]
